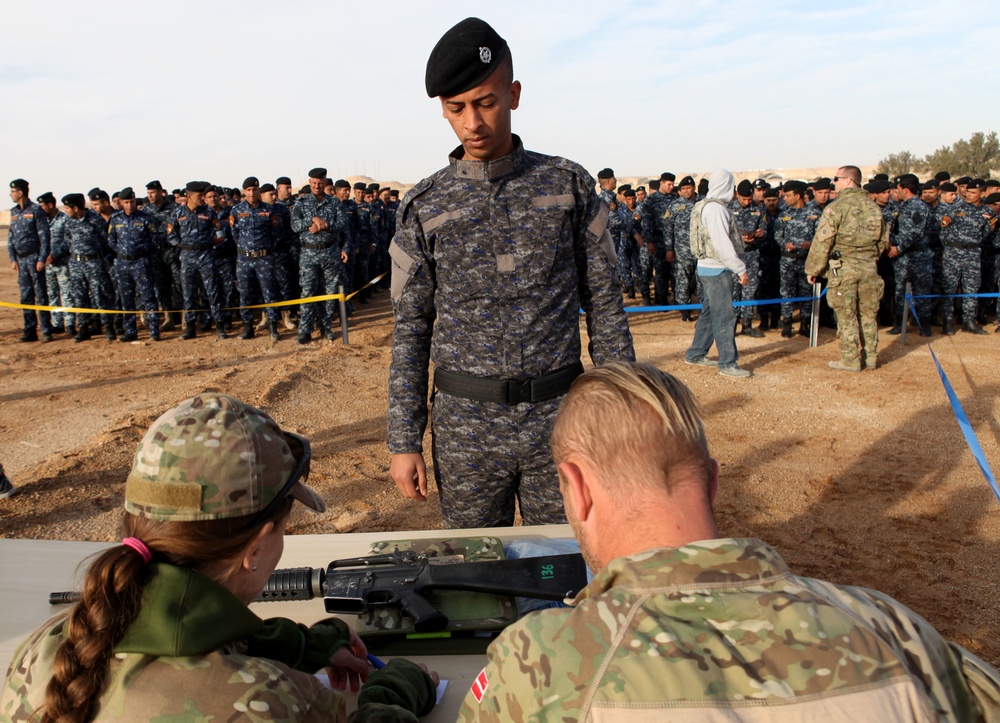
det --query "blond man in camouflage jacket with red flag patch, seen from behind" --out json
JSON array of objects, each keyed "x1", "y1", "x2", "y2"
[{"x1": 460, "y1": 364, "x2": 1000, "y2": 723}]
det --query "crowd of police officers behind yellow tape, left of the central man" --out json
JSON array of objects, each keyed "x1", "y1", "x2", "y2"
[{"x1": 7, "y1": 175, "x2": 399, "y2": 344}]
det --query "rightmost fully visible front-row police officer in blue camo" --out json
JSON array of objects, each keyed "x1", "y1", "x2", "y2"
[{"x1": 936, "y1": 178, "x2": 991, "y2": 334}]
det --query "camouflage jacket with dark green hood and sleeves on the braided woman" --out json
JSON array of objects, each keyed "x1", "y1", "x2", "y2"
[{"x1": 0, "y1": 564, "x2": 434, "y2": 723}]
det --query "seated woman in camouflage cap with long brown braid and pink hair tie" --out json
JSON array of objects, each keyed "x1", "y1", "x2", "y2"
[{"x1": 0, "y1": 394, "x2": 437, "y2": 723}]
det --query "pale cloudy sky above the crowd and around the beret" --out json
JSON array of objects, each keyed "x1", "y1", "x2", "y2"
[{"x1": 0, "y1": 0, "x2": 1000, "y2": 197}]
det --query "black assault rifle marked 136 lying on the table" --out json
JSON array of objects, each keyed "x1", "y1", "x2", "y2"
[{"x1": 49, "y1": 550, "x2": 587, "y2": 632}]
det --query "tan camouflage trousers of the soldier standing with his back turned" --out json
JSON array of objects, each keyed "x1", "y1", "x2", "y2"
[{"x1": 826, "y1": 259, "x2": 885, "y2": 365}]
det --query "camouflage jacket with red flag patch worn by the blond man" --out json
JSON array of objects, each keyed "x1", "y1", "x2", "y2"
[{"x1": 461, "y1": 539, "x2": 1000, "y2": 723}]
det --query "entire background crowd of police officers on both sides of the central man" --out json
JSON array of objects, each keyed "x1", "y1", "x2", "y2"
[{"x1": 7, "y1": 168, "x2": 1000, "y2": 344}]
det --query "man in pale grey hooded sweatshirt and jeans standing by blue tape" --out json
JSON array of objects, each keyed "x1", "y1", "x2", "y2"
[{"x1": 684, "y1": 168, "x2": 750, "y2": 377}]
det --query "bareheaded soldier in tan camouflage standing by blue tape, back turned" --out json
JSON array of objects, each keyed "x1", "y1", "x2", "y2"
[{"x1": 806, "y1": 166, "x2": 888, "y2": 372}]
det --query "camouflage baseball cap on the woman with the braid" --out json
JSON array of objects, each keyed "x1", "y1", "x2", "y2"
[{"x1": 125, "y1": 393, "x2": 326, "y2": 527}]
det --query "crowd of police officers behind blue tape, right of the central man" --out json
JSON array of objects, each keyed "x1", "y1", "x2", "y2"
[{"x1": 598, "y1": 168, "x2": 1000, "y2": 337}]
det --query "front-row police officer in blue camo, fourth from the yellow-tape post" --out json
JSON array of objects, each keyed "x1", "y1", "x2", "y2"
[{"x1": 108, "y1": 187, "x2": 160, "y2": 342}]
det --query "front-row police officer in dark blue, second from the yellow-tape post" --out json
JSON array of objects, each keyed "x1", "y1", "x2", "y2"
[{"x1": 229, "y1": 176, "x2": 281, "y2": 341}]
